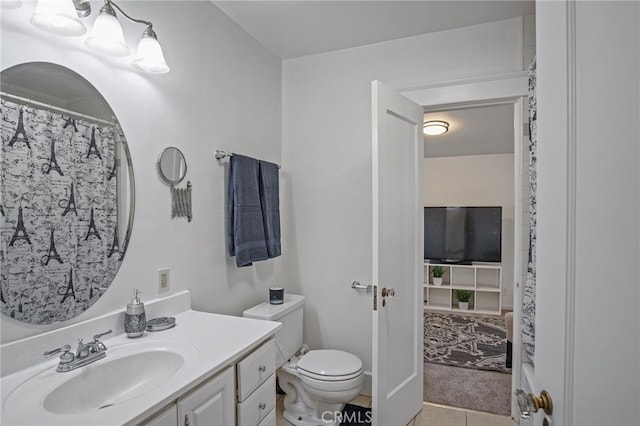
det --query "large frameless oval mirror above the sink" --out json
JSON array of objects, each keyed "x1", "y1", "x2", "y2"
[{"x1": 0, "y1": 62, "x2": 134, "y2": 324}]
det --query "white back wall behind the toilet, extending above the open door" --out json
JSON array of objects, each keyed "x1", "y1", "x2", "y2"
[{"x1": 282, "y1": 19, "x2": 522, "y2": 390}]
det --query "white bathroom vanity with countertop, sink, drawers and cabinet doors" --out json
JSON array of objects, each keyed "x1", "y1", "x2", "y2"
[{"x1": 0, "y1": 292, "x2": 282, "y2": 426}]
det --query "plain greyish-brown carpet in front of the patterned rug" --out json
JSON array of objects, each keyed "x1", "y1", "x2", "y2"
[{"x1": 424, "y1": 363, "x2": 511, "y2": 416}]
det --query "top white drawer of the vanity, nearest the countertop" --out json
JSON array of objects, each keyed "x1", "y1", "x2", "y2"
[{"x1": 238, "y1": 339, "x2": 276, "y2": 402}]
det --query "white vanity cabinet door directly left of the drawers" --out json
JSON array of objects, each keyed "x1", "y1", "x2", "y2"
[{"x1": 178, "y1": 366, "x2": 236, "y2": 426}]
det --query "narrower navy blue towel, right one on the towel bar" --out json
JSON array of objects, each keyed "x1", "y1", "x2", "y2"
[{"x1": 260, "y1": 161, "x2": 282, "y2": 258}]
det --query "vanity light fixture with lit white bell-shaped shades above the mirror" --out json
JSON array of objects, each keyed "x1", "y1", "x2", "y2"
[{"x1": 31, "y1": 0, "x2": 169, "y2": 74}]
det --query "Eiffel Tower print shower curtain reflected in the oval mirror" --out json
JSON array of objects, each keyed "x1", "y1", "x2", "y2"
[{"x1": 0, "y1": 100, "x2": 124, "y2": 324}]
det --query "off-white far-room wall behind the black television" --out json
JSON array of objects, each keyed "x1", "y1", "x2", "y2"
[{"x1": 424, "y1": 154, "x2": 514, "y2": 307}]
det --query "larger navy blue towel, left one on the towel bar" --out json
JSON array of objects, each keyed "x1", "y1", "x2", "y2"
[{"x1": 227, "y1": 155, "x2": 269, "y2": 266}]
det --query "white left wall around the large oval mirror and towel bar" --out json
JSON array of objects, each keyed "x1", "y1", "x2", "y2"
[{"x1": 0, "y1": 1, "x2": 288, "y2": 342}]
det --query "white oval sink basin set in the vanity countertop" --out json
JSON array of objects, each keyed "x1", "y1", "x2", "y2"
[{"x1": 4, "y1": 341, "x2": 197, "y2": 414}]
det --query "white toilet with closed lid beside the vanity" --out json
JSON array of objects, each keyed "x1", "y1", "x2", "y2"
[{"x1": 243, "y1": 294, "x2": 364, "y2": 426}]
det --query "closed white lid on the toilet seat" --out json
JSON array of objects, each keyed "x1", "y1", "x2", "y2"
[{"x1": 298, "y1": 349, "x2": 362, "y2": 377}]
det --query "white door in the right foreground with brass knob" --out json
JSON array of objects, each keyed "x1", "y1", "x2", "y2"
[{"x1": 520, "y1": 0, "x2": 640, "y2": 426}]
